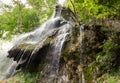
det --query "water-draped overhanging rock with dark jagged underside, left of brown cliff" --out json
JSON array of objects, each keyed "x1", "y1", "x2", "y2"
[{"x1": 4, "y1": 6, "x2": 75, "y2": 81}]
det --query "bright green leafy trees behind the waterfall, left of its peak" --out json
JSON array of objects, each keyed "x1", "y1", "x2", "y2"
[{"x1": 0, "y1": 0, "x2": 55, "y2": 38}]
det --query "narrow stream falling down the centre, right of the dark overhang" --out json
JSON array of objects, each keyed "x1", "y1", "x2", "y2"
[{"x1": 51, "y1": 29, "x2": 68, "y2": 73}]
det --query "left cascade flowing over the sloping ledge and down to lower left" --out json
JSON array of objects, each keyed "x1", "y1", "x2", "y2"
[{"x1": 0, "y1": 17, "x2": 64, "y2": 79}]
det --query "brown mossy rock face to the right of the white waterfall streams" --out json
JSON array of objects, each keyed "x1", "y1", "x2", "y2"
[{"x1": 62, "y1": 24, "x2": 120, "y2": 83}]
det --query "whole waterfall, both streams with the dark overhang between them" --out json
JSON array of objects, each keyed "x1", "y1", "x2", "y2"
[{"x1": 0, "y1": 6, "x2": 74, "y2": 83}]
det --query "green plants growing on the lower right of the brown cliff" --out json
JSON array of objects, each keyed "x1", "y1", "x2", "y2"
[{"x1": 83, "y1": 28, "x2": 120, "y2": 83}]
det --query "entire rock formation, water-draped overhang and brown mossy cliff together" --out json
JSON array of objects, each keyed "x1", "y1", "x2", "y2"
[{"x1": 3, "y1": 6, "x2": 120, "y2": 83}]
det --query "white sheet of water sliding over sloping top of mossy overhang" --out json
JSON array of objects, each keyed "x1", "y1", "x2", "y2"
[{"x1": 15, "y1": 17, "x2": 61, "y2": 44}]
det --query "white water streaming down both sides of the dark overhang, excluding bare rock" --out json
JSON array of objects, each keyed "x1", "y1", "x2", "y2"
[{"x1": 0, "y1": 6, "x2": 73, "y2": 83}]
